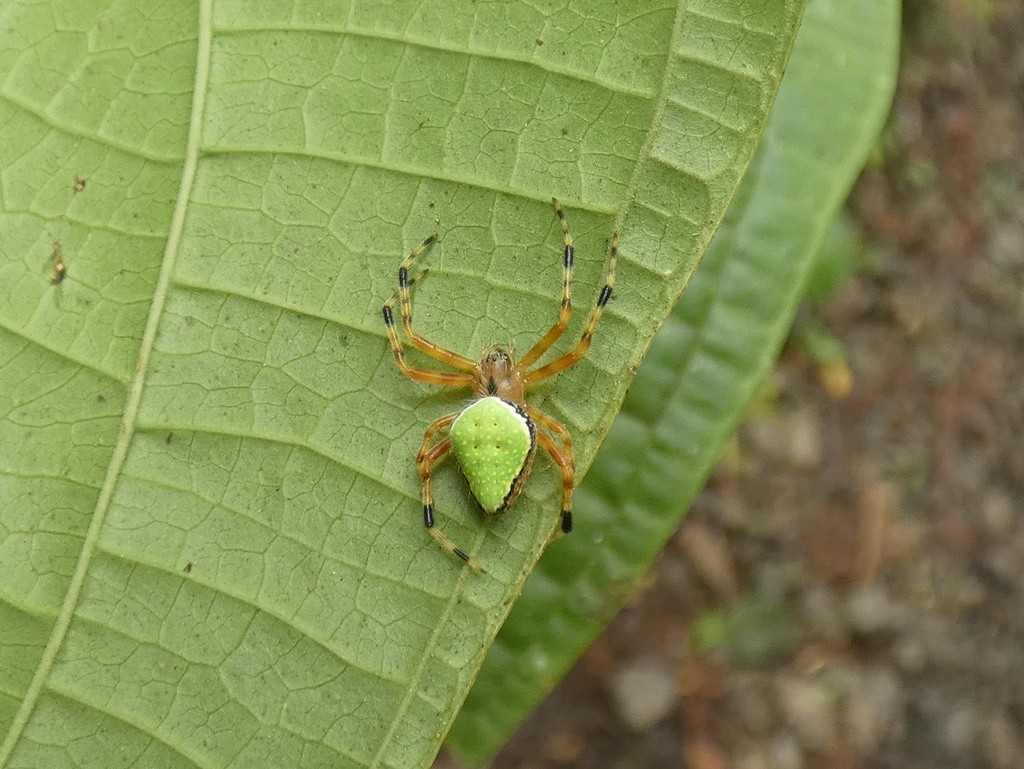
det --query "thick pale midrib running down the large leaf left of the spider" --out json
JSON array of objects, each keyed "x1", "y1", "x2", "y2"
[{"x1": 0, "y1": 0, "x2": 213, "y2": 769}]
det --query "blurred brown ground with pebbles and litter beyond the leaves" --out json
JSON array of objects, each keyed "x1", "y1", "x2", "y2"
[{"x1": 437, "y1": 0, "x2": 1024, "y2": 769}]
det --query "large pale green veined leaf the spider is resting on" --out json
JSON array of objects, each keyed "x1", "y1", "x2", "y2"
[{"x1": 0, "y1": 0, "x2": 802, "y2": 768}]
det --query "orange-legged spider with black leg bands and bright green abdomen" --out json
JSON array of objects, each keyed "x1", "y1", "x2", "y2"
[{"x1": 382, "y1": 198, "x2": 618, "y2": 572}]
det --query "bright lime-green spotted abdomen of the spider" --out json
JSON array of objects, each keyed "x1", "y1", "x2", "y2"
[{"x1": 449, "y1": 396, "x2": 537, "y2": 514}]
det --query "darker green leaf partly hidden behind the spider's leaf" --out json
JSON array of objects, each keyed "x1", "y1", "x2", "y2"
[{"x1": 449, "y1": 0, "x2": 899, "y2": 763}]
